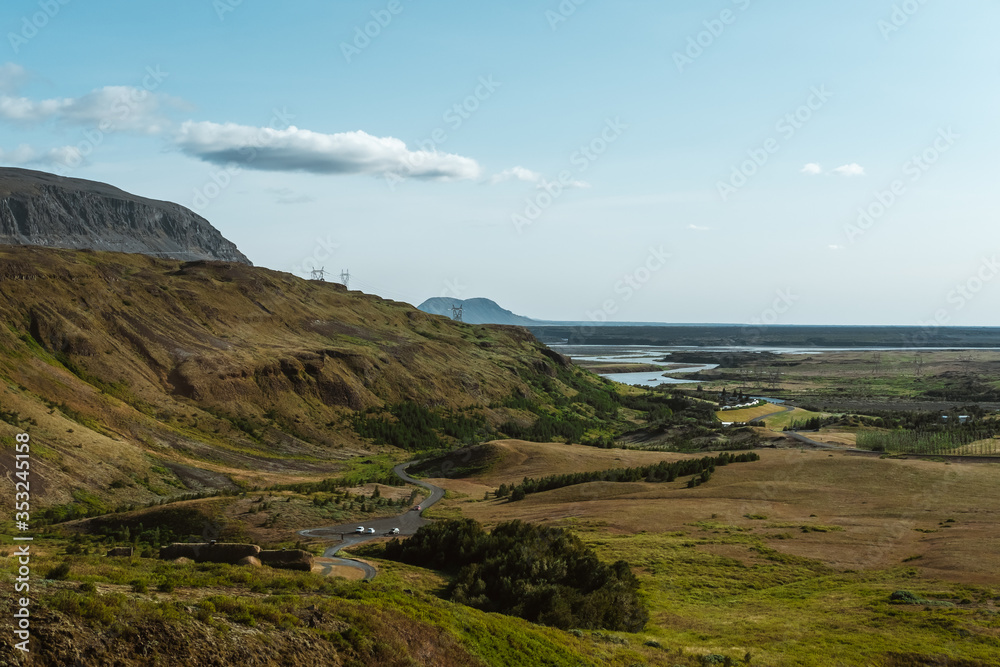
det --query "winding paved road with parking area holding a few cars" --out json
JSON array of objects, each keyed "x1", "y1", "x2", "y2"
[{"x1": 299, "y1": 461, "x2": 444, "y2": 580}]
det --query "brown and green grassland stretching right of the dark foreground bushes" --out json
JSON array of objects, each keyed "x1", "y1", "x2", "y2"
[{"x1": 412, "y1": 441, "x2": 1000, "y2": 666}]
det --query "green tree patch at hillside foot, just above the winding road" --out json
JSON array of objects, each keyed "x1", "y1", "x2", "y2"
[{"x1": 353, "y1": 401, "x2": 494, "y2": 451}]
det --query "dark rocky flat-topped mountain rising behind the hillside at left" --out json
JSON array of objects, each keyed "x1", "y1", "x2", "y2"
[{"x1": 0, "y1": 168, "x2": 250, "y2": 264}]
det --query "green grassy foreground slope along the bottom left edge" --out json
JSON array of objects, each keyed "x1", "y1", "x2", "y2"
[{"x1": 0, "y1": 540, "x2": 672, "y2": 667}]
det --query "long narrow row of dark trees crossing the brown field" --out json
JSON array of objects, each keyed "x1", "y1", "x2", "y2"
[{"x1": 496, "y1": 452, "x2": 760, "y2": 502}]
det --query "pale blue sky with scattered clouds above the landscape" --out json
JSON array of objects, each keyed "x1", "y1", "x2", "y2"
[{"x1": 0, "y1": 0, "x2": 1000, "y2": 327}]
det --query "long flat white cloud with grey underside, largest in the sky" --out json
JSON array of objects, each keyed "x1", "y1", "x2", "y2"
[{"x1": 176, "y1": 121, "x2": 482, "y2": 180}]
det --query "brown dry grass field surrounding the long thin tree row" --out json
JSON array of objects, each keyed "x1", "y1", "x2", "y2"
[{"x1": 431, "y1": 441, "x2": 1000, "y2": 585}]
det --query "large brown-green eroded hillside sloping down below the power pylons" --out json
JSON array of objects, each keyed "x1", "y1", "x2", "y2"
[{"x1": 0, "y1": 248, "x2": 628, "y2": 515}]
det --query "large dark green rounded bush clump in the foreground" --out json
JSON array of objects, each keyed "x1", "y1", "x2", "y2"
[{"x1": 385, "y1": 519, "x2": 649, "y2": 632}]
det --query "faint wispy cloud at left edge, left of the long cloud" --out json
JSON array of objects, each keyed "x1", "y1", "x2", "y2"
[{"x1": 0, "y1": 85, "x2": 185, "y2": 134}]
